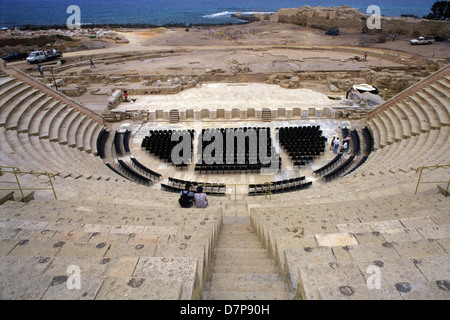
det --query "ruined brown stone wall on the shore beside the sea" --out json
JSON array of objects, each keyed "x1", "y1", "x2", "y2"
[{"x1": 266, "y1": 6, "x2": 450, "y2": 38}]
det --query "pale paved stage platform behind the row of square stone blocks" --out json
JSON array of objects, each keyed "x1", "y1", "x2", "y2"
[{"x1": 114, "y1": 83, "x2": 341, "y2": 112}]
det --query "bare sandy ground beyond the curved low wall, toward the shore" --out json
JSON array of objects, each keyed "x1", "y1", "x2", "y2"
[{"x1": 25, "y1": 21, "x2": 442, "y2": 58}]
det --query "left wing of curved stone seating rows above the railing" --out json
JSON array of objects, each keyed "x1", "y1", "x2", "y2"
[{"x1": 0, "y1": 69, "x2": 122, "y2": 180}]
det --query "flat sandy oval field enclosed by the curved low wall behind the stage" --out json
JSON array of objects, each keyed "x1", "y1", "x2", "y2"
[{"x1": 70, "y1": 47, "x2": 406, "y2": 74}]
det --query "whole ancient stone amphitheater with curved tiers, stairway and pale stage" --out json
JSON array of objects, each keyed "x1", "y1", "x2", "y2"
[{"x1": 0, "y1": 23, "x2": 450, "y2": 300}]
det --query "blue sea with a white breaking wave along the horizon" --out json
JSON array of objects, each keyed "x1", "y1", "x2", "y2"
[{"x1": 0, "y1": 0, "x2": 435, "y2": 27}]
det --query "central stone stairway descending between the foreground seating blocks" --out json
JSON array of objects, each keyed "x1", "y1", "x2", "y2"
[{"x1": 203, "y1": 223, "x2": 291, "y2": 300}]
